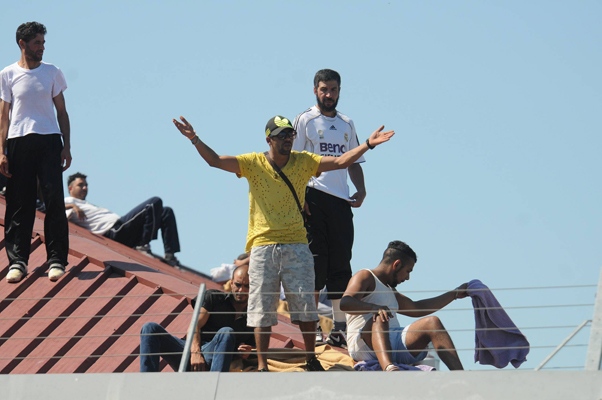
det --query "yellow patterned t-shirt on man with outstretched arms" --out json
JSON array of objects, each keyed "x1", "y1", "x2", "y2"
[{"x1": 236, "y1": 151, "x2": 322, "y2": 251}]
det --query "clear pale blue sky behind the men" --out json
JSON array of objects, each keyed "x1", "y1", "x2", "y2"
[{"x1": 0, "y1": 0, "x2": 602, "y2": 369}]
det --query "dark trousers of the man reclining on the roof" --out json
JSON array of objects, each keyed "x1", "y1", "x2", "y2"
[{"x1": 104, "y1": 197, "x2": 180, "y2": 254}]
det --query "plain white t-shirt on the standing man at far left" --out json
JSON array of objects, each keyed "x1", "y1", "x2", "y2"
[{"x1": 0, "y1": 63, "x2": 67, "y2": 139}]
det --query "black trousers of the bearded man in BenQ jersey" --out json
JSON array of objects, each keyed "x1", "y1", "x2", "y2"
[{"x1": 305, "y1": 188, "x2": 354, "y2": 299}]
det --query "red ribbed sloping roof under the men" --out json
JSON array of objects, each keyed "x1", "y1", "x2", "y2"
[{"x1": 0, "y1": 196, "x2": 303, "y2": 374}]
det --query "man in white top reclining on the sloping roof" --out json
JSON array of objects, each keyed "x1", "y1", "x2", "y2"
[{"x1": 65, "y1": 172, "x2": 180, "y2": 266}]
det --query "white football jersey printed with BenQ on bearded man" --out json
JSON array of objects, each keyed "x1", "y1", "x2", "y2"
[{"x1": 293, "y1": 106, "x2": 365, "y2": 200}]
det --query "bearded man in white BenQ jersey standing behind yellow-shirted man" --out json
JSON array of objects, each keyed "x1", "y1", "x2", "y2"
[{"x1": 293, "y1": 69, "x2": 366, "y2": 348}]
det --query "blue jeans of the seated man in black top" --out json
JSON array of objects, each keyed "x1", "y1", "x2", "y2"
[{"x1": 140, "y1": 322, "x2": 236, "y2": 372}]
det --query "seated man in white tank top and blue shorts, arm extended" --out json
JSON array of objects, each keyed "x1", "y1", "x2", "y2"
[{"x1": 341, "y1": 240, "x2": 468, "y2": 371}]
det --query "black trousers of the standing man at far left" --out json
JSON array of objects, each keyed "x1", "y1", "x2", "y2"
[{"x1": 4, "y1": 134, "x2": 69, "y2": 265}]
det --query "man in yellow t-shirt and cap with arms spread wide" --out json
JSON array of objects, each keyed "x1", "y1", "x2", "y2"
[{"x1": 173, "y1": 115, "x2": 395, "y2": 371}]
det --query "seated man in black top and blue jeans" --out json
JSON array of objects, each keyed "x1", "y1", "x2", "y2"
[{"x1": 140, "y1": 265, "x2": 255, "y2": 372}]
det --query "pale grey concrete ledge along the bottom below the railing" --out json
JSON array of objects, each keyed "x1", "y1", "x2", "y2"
[{"x1": 0, "y1": 370, "x2": 602, "y2": 400}]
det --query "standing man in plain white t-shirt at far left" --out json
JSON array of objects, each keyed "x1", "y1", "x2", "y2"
[{"x1": 0, "y1": 22, "x2": 71, "y2": 283}]
